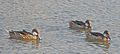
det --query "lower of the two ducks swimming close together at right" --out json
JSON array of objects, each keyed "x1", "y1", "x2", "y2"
[{"x1": 86, "y1": 30, "x2": 111, "y2": 42}]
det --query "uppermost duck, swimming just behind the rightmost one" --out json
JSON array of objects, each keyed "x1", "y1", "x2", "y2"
[{"x1": 69, "y1": 20, "x2": 91, "y2": 29}]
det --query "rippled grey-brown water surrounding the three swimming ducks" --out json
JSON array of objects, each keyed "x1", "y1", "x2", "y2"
[{"x1": 0, "y1": 0, "x2": 120, "y2": 54}]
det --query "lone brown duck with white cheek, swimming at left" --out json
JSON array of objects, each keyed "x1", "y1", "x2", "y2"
[{"x1": 9, "y1": 29, "x2": 40, "y2": 40}]
